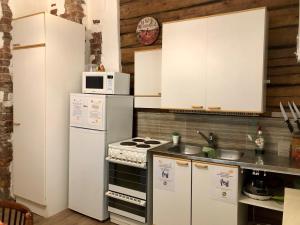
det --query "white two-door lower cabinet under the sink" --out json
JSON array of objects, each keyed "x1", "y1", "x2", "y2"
[{"x1": 153, "y1": 156, "x2": 246, "y2": 225}]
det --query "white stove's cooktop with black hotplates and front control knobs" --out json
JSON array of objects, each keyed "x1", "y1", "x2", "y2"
[{"x1": 106, "y1": 137, "x2": 168, "y2": 168}]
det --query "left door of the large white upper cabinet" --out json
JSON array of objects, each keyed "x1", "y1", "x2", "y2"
[{"x1": 162, "y1": 19, "x2": 207, "y2": 109}]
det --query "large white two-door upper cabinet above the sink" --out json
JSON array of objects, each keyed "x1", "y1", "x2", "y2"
[{"x1": 162, "y1": 8, "x2": 266, "y2": 113}]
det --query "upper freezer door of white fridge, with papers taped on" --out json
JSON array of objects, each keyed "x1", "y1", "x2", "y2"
[{"x1": 70, "y1": 94, "x2": 107, "y2": 130}]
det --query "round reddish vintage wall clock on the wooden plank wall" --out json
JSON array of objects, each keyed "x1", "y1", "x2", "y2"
[{"x1": 136, "y1": 17, "x2": 159, "y2": 45}]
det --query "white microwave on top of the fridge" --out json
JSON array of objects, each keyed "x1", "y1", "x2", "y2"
[{"x1": 82, "y1": 72, "x2": 130, "y2": 95}]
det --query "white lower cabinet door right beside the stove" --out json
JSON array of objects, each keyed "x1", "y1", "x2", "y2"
[{"x1": 153, "y1": 156, "x2": 191, "y2": 225}]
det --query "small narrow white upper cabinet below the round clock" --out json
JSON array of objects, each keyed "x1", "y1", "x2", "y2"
[{"x1": 134, "y1": 49, "x2": 161, "y2": 108}]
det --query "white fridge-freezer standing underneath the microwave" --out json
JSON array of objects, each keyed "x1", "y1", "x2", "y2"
[{"x1": 69, "y1": 94, "x2": 133, "y2": 221}]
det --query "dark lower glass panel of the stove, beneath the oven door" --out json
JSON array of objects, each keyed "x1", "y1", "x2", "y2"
[{"x1": 108, "y1": 198, "x2": 147, "y2": 218}]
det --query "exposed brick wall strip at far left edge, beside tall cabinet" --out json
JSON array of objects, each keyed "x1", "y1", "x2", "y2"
[{"x1": 0, "y1": 0, "x2": 13, "y2": 199}]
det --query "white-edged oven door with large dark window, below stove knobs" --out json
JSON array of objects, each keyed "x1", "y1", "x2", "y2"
[{"x1": 108, "y1": 162, "x2": 147, "y2": 200}]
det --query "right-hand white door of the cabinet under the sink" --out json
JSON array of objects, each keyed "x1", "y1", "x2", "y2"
[{"x1": 192, "y1": 162, "x2": 238, "y2": 225}]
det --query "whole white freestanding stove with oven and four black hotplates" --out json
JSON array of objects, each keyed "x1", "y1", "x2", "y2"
[{"x1": 106, "y1": 137, "x2": 168, "y2": 225}]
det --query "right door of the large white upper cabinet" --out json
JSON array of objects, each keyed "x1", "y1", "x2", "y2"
[{"x1": 206, "y1": 9, "x2": 266, "y2": 113}]
